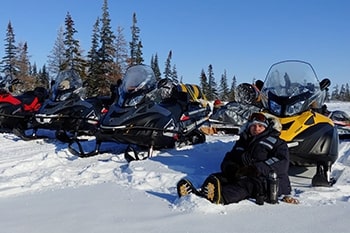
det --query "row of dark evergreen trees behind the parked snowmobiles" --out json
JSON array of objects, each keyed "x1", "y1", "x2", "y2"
[{"x1": 0, "y1": 0, "x2": 350, "y2": 101}]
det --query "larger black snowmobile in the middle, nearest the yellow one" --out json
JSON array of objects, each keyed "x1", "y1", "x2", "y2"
[{"x1": 69, "y1": 65, "x2": 210, "y2": 161}]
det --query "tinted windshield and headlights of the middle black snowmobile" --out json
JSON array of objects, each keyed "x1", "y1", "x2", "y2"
[{"x1": 118, "y1": 65, "x2": 157, "y2": 107}]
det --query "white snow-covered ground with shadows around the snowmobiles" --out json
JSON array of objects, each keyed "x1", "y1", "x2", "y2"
[{"x1": 0, "y1": 103, "x2": 350, "y2": 233}]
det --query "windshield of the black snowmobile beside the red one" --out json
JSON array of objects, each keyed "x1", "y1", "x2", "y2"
[{"x1": 50, "y1": 70, "x2": 85, "y2": 101}]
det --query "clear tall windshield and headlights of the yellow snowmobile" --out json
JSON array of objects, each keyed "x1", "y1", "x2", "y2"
[{"x1": 261, "y1": 60, "x2": 326, "y2": 117}]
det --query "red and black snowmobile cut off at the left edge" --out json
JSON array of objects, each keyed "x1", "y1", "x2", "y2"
[{"x1": 0, "y1": 75, "x2": 48, "y2": 132}]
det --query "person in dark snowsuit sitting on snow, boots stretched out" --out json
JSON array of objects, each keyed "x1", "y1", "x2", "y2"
[{"x1": 177, "y1": 112, "x2": 296, "y2": 205}]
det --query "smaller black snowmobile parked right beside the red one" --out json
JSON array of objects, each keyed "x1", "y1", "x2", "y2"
[{"x1": 19, "y1": 70, "x2": 101, "y2": 142}]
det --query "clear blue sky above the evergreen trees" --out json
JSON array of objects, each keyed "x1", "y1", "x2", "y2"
[{"x1": 0, "y1": 0, "x2": 350, "y2": 88}]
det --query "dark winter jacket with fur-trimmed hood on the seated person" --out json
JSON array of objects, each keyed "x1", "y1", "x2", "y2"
[{"x1": 221, "y1": 116, "x2": 291, "y2": 195}]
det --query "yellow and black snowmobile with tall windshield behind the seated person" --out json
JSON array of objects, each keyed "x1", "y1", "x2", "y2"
[{"x1": 239, "y1": 60, "x2": 339, "y2": 186}]
